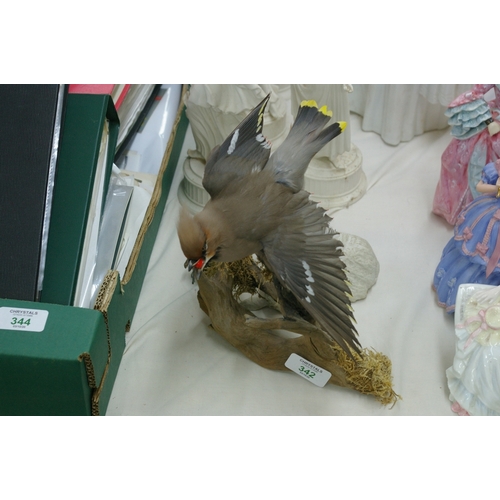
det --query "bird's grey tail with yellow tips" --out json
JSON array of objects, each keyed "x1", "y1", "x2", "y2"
[{"x1": 265, "y1": 100, "x2": 346, "y2": 192}]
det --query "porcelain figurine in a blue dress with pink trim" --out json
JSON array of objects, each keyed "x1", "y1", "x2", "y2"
[{"x1": 433, "y1": 160, "x2": 500, "y2": 313}]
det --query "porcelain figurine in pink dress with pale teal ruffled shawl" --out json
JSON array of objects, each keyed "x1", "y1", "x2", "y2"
[{"x1": 432, "y1": 84, "x2": 500, "y2": 224}]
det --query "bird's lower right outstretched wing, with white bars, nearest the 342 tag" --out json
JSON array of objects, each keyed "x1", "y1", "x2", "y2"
[{"x1": 262, "y1": 191, "x2": 360, "y2": 356}]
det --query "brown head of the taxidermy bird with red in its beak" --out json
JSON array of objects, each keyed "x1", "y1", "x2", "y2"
[{"x1": 177, "y1": 208, "x2": 217, "y2": 283}]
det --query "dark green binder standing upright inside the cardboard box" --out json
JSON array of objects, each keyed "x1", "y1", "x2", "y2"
[{"x1": 40, "y1": 94, "x2": 119, "y2": 305}]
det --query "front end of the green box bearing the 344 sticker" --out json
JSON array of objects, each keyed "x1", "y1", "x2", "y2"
[{"x1": 0, "y1": 300, "x2": 108, "y2": 415}]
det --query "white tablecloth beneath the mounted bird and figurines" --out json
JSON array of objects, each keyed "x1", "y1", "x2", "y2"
[{"x1": 107, "y1": 114, "x2": 455, "y2": 416}]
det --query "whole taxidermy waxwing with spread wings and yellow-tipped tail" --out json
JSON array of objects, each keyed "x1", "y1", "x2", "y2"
[{"x1": 177, "y1": 95, "x2": 360, "y2": 356}]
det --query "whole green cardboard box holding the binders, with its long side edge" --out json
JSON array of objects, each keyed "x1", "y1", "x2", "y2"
[{"x1": 0, "y1": 85, "x2": 188, "y2": 415}]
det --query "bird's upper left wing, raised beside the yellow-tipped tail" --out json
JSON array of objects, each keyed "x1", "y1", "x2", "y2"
[{"x1": 203, "y1": 94, "x2": 271, "y2": 198}]
